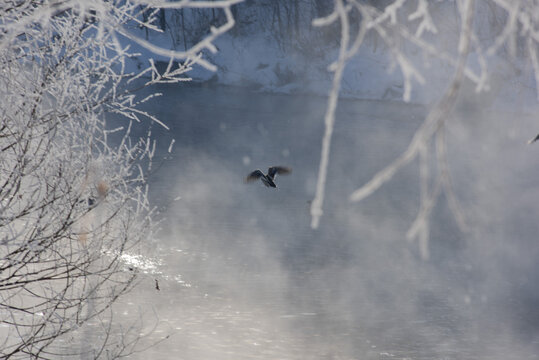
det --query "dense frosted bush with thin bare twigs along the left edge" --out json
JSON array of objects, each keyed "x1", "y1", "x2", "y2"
[{"x1": 0, "y1": 0, "x2": 239, "y2": 358}]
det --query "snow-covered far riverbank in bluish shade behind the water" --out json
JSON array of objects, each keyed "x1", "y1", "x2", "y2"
[{"x1": 125, "y1": 14, "x2": 537, "y2": 110}]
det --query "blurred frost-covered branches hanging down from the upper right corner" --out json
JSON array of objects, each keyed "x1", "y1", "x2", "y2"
[{"x1": 311, "y1": 0, "x2": 539, "y2": 258}]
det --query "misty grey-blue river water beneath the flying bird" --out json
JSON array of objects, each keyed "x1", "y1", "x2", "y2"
[{"x1": 116, "y1": 85, "x2": 539, "y2": 360}]
